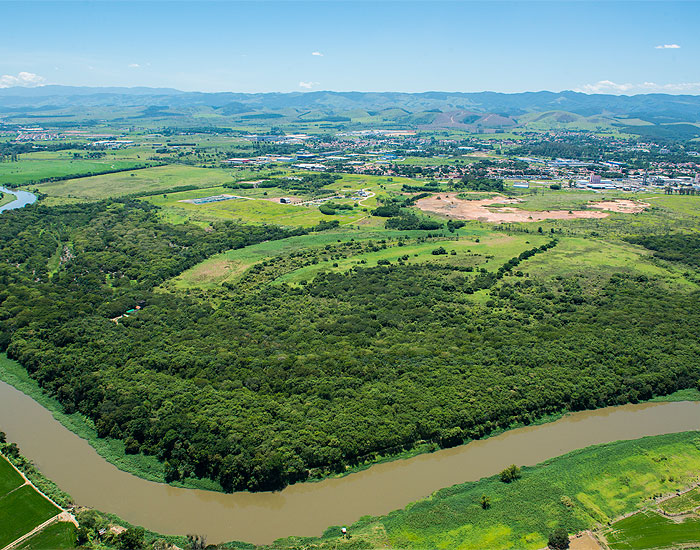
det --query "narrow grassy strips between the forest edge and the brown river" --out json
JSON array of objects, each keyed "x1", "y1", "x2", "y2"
[{"x1": 0, "y1": 353, "x2": 700, "y2": 498}]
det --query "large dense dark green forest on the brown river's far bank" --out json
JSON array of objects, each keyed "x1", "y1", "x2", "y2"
[{"x1": 0, "y1": 199, "x2": 700, "y2": 491}]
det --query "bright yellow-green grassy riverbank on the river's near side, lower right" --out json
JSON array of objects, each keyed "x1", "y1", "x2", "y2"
[{"x1": 269, "y1": 432, "x2": 700, "y2": 550}]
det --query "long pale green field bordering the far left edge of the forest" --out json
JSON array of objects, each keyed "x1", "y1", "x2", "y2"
[{"x1": 38, "y1": 164, "x2": 233, "y2": 200}]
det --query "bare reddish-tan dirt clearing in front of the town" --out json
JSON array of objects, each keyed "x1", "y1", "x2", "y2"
[{"x1": 416, "y1": 193, "x2": 648, "y2": 223}]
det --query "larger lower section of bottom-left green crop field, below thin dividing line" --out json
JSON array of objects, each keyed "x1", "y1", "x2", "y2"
[{"x1": 0, "y1": 485, "x2": 60, "y2": 548}]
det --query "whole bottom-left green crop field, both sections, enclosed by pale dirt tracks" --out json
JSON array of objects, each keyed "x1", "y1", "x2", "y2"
[{"x1": 0, "y1": 457, "x2": 60, "y2": 548}]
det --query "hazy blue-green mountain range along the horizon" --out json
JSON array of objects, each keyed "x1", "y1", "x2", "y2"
[{"x1": 0, "y1": 86, "x2": 700, "y2": 139}]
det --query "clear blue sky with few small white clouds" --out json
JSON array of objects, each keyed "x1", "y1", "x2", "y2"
[{"x1": 0, "y1": 0, "x2": 700, "y2": 94}]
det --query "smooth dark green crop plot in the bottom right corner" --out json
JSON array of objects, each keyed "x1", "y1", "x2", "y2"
[{"x1": 603, "y1": 511, "x2": 700, "y2": 550}]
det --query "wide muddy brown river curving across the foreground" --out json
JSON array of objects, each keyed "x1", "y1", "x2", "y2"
[{"x1": 0, "y1": 382, "x2": 700, "y2": 544}]
